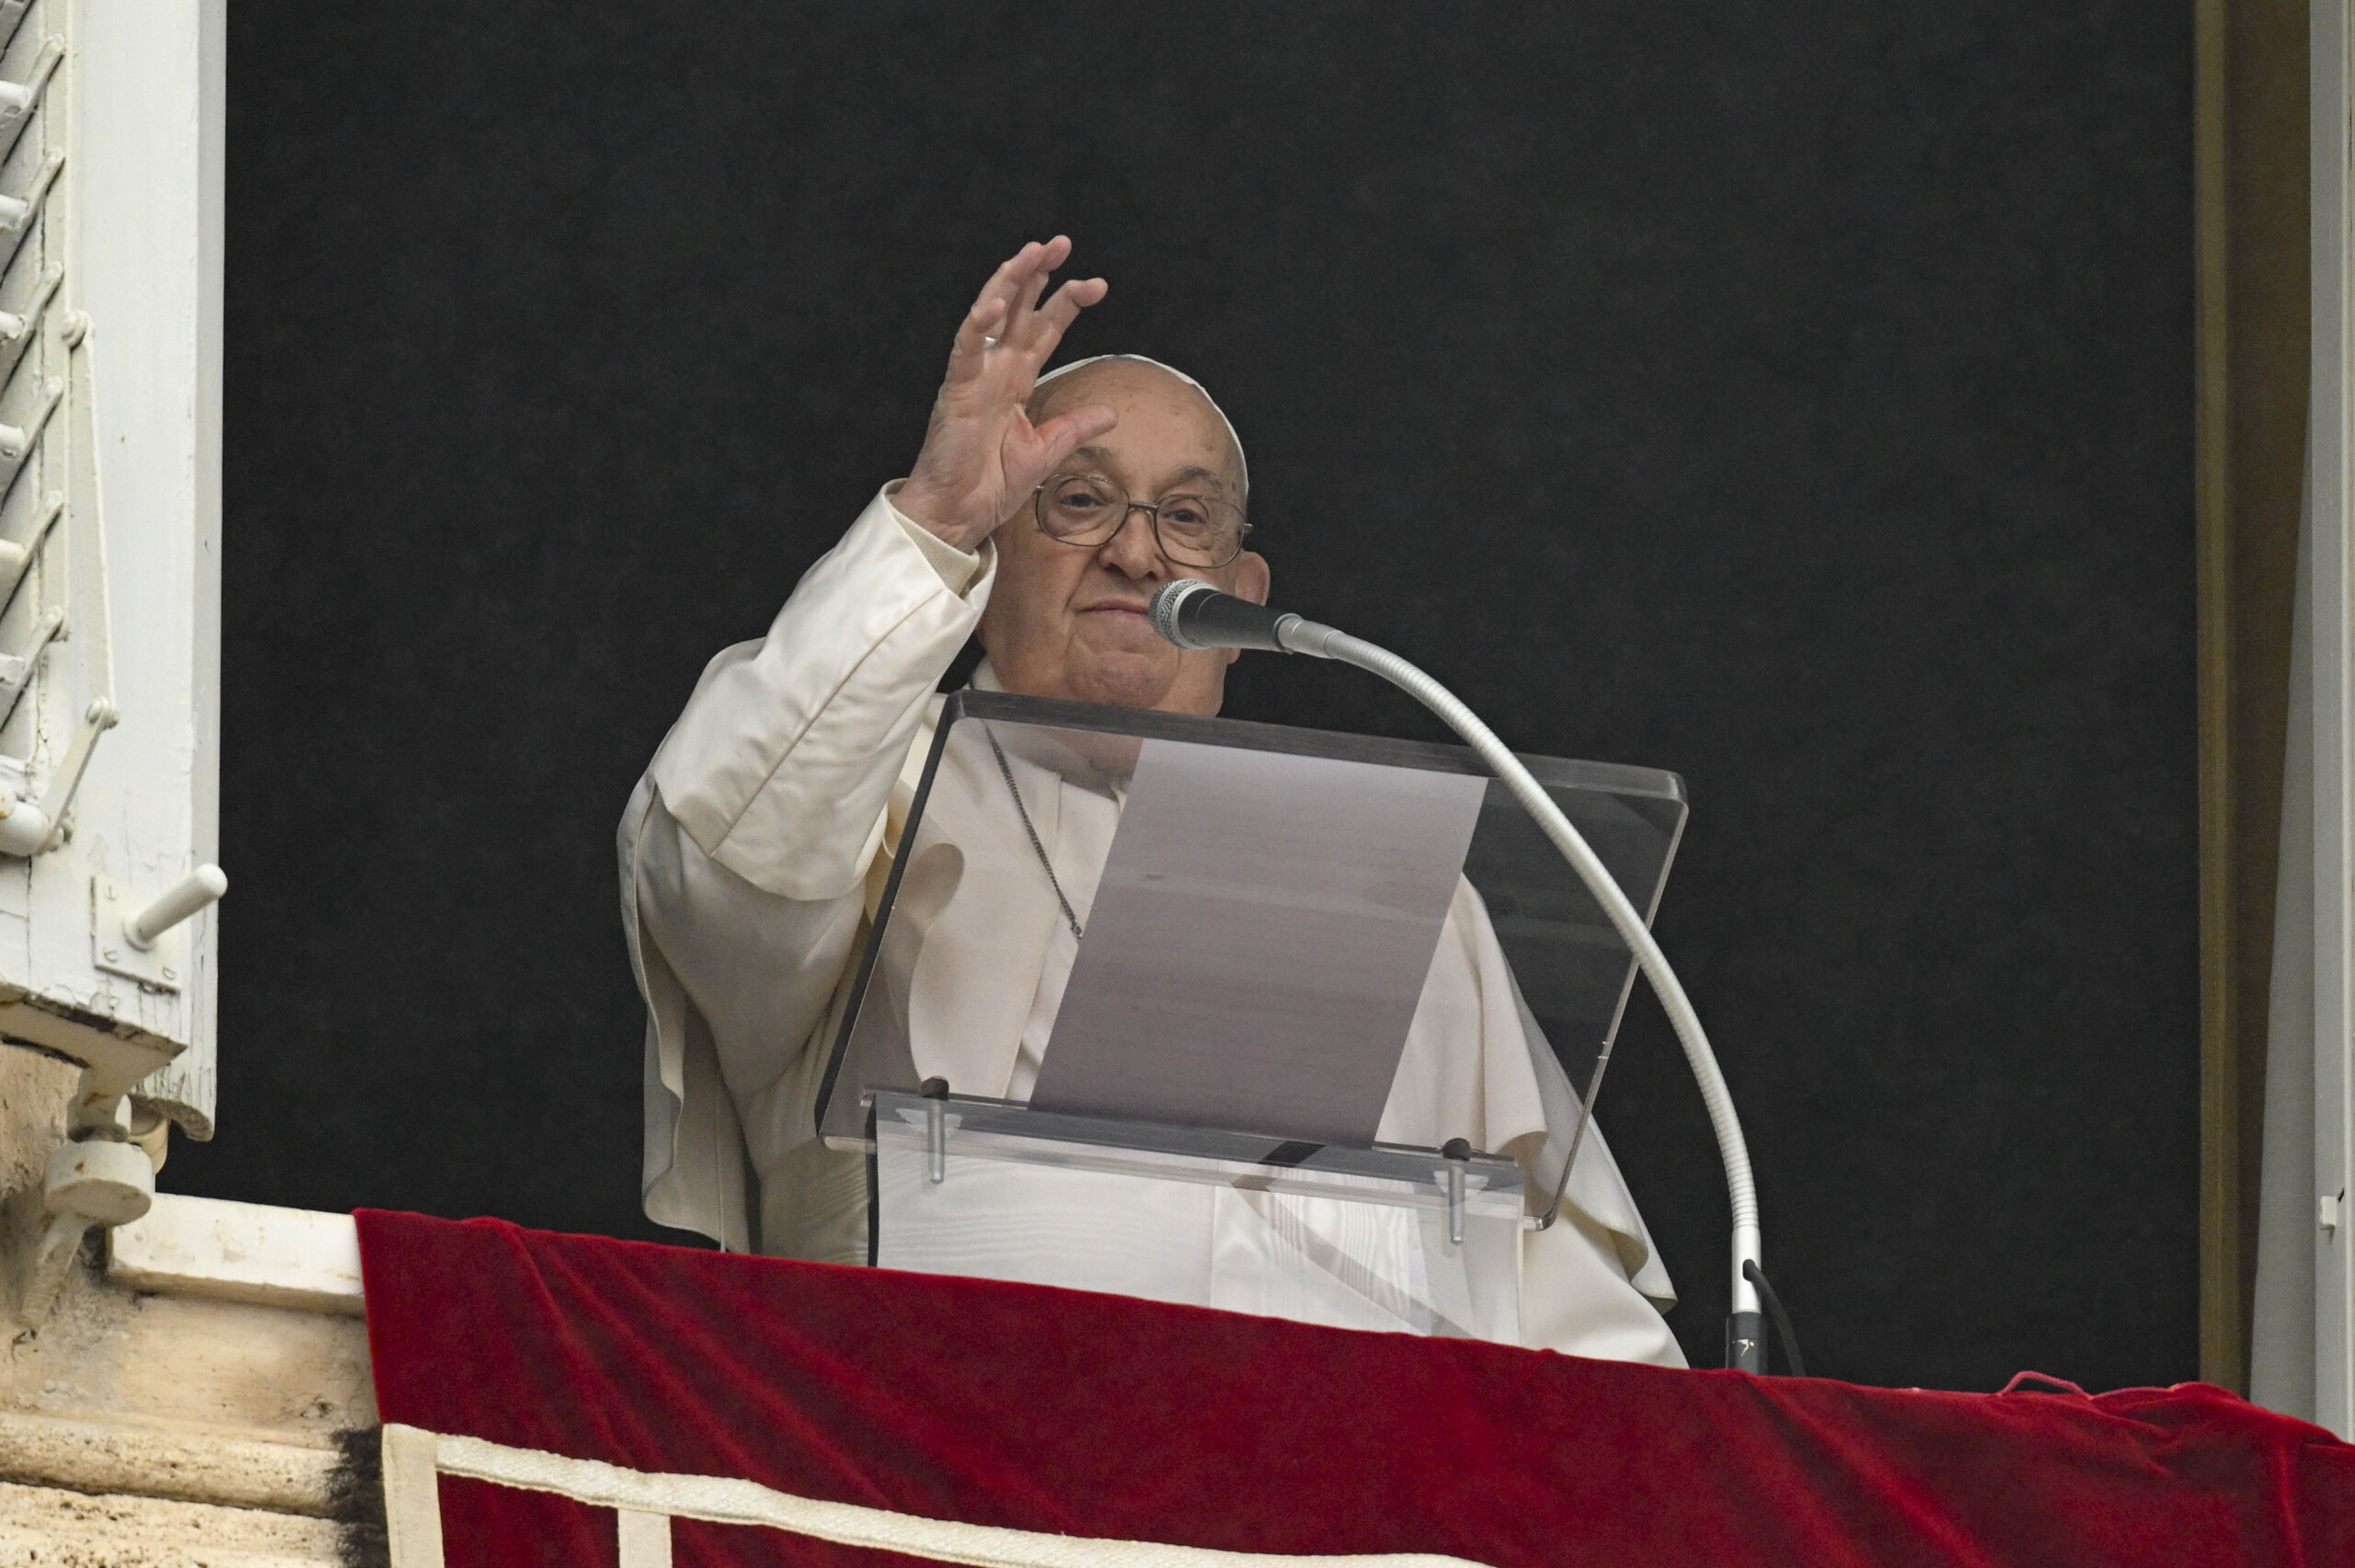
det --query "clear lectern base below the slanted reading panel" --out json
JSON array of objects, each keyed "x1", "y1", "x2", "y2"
[{"x1": 874, "y1": 1093, "x2": 1522, "y2": 1345}]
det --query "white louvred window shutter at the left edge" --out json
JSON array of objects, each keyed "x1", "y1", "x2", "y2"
[{"x1": 0, "y1": 0, "x2": 226, "y2": 1138}]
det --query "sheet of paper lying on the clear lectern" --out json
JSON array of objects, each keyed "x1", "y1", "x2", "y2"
[{"x1": 1031, "y1": 739, "x2": 1486, "y2": 1147}]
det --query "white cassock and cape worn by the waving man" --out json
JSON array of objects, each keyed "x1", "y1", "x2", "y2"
[{"x1": 619, "y1": 482, "x2": 1683, "y2": 1366}]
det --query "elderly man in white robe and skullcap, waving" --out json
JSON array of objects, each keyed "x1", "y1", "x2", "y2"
[{"x1": 619, "y1": 238, "x2": 1683, "y2": 1366}]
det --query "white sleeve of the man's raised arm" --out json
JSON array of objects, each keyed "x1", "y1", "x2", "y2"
[{"x1": 617, "y1": 482, "x2": 996, "y2": 1250}]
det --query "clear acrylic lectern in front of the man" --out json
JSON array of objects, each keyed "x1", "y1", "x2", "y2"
[{"x1": 817, "y1": 690, "x2": 1683, "y2": 1342}]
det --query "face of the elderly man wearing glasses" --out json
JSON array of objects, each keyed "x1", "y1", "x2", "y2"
[{"x1": 982, "y1": 361, "x2": 1267, "y2": 714}]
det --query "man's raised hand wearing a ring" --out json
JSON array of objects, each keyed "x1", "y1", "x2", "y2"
[{"x1": 892, "y1": 235, "x2": 1119, "y2": 551}]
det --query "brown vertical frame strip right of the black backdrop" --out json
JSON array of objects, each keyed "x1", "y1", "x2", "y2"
[{"x1": 2192, "y1": 0, "x2": 2307, "y2": 1391}]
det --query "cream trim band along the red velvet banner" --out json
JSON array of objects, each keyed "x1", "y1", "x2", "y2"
[{"x1": 384, "y1": 1422, "x2": 1481, "y2": 1568}]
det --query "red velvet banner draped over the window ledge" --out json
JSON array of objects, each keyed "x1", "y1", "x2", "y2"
[{"x1": 358, "y1": 1210, "x2": 2355, "y2": 1568}]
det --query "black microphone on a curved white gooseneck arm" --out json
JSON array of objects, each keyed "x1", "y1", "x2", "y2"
[{"x1": 1152, "y1": 577, "x2": 1766, "y2": 1373}]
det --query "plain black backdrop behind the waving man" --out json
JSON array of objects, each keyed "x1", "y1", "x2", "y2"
[{"x1": 165, "y1": 0, "x2": 2197, "y2": 1387}]
